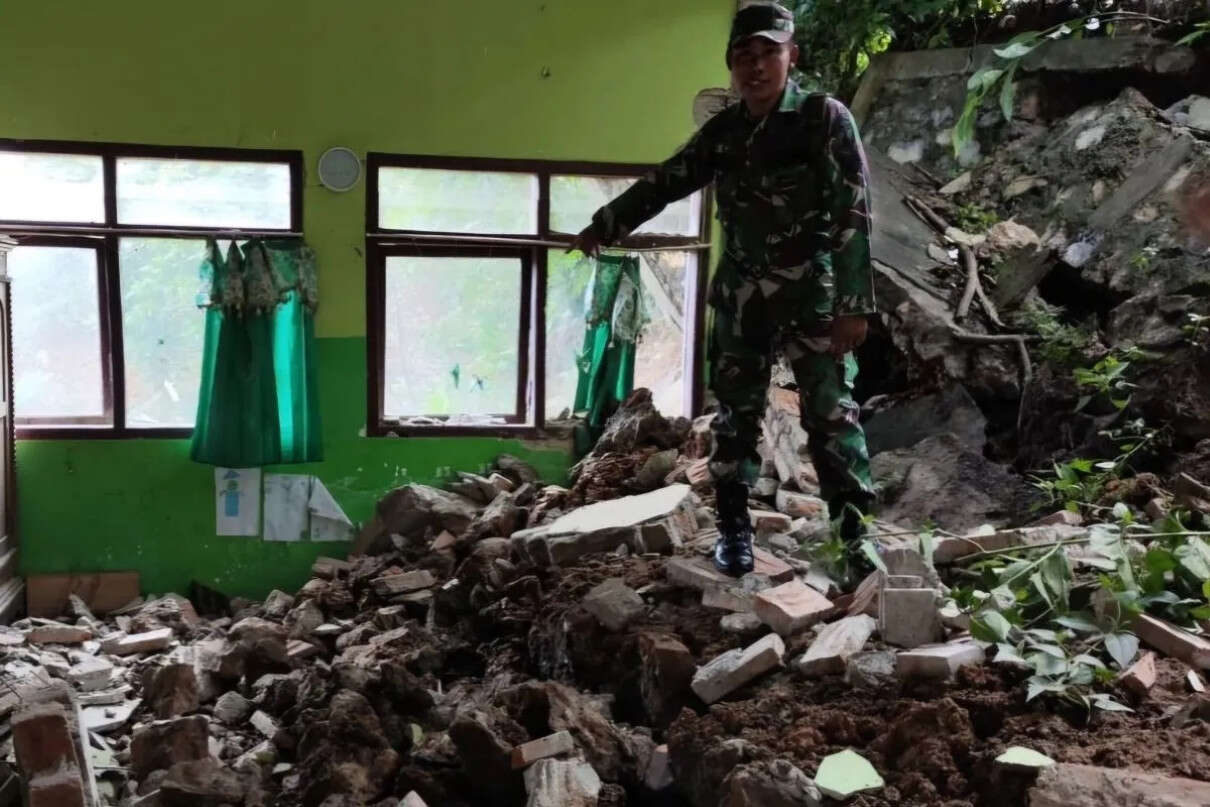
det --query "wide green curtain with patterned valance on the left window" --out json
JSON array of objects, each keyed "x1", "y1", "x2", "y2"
[{"x1": 190, "y1": 238, "x2": 323, "y2": 468}]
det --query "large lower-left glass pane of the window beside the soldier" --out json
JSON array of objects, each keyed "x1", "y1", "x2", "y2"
[{"x1": 382, "y1": 255, "x2": 522, "y2": 421}]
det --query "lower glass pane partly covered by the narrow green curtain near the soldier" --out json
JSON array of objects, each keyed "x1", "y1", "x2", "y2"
[{"x1": 546, "y1": 249, "x2": 697, "y2": 420}]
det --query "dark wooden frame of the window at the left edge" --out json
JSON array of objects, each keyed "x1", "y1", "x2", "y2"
[{"x1": 0, "y1": 138, "x2": 304, "y2": 439}]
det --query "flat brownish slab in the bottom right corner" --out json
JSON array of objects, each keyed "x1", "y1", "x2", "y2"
[{"x1": 1029, "y1": 763, "x2": 1210, "y2": 807}]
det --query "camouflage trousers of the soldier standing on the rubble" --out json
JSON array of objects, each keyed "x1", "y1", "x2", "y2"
[{"x1": 709, "y1": 299, "x2": 874, "y2": 518}]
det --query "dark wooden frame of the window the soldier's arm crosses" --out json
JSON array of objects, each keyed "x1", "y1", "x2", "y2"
[{"x1": 365, "y1": 151, "x2": 711, "y2": 438}]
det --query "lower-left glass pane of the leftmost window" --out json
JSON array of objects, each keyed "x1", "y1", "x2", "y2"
[{"x1": 8, "y1": 247, "x2": 105, "y2": 422}]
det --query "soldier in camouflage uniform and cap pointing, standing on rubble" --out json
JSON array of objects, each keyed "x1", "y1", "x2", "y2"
[{"x1": 574, "y1": 2, "x2": 875, "y2": 575}]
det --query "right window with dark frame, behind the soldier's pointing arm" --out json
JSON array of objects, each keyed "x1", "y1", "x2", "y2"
[{"x1": 367, "y1": 154, "x2": 708, "y2": 434}]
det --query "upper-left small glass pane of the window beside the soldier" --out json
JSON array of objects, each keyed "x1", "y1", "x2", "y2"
[{"x1": 378, "y1": 168, "x2": 538, "y2": 235}]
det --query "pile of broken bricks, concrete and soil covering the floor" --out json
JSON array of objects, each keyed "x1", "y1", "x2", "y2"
[{"x1": 7, "y1": 391, "x2": 1210, "y2": 807}]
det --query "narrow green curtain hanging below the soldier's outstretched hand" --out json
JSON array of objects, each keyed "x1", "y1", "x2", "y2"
[{"x1": 574, "y1": 255, "x2": 647, "y2": 438}]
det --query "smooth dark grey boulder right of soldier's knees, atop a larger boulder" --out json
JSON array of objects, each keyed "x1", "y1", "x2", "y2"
[{"x1": 862, "y1": 384, "x2": 987, "y2": 457}]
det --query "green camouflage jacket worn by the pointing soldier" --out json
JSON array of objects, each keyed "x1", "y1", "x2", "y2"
[{"x1": 593, "y1": 82, "x2": 874, "y2": 324}]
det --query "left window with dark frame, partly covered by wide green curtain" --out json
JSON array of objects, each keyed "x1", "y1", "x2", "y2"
[{"x1": 0, "y1": 142, "x2": 303, "y2": 437}]
